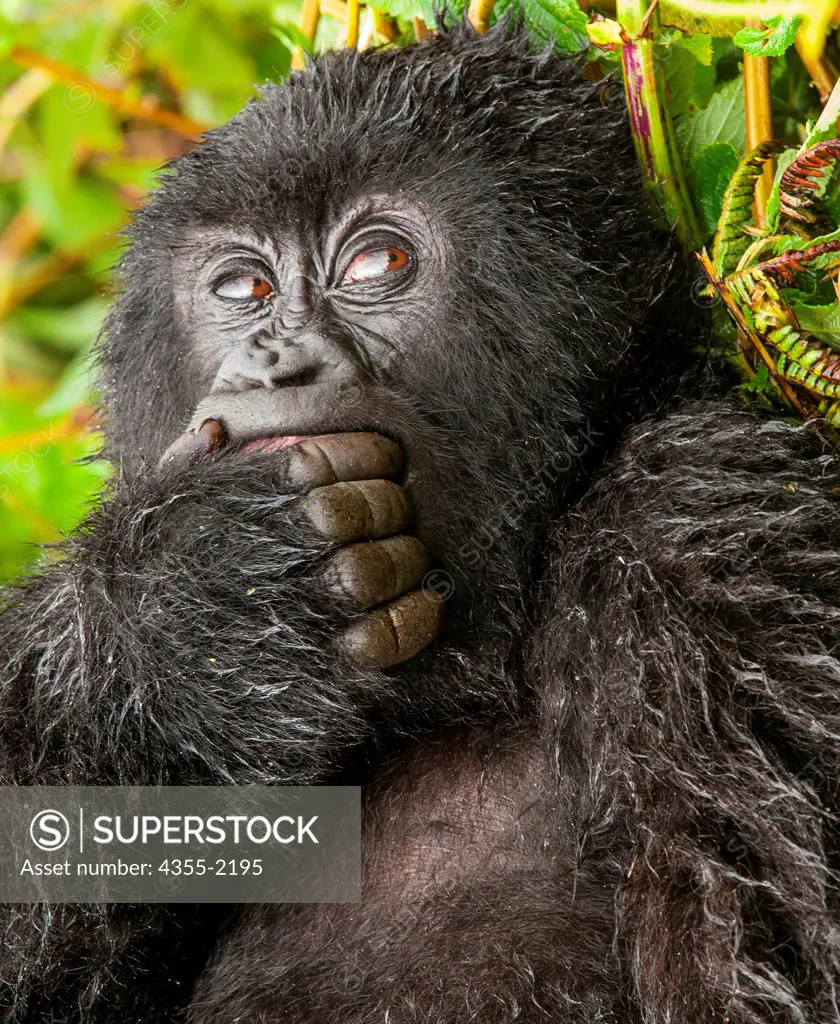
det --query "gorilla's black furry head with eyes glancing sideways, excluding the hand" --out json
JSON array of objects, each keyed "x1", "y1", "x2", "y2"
[{"x1": 102, "y1": 26, "x2": 684, "y2": 630}]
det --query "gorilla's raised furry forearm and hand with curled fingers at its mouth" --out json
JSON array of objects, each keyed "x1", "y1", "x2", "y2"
[{"x1": 0, "y1": 424, "x2": 442, "y2": 784}]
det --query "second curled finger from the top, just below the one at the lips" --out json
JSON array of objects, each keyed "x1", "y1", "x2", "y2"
[{"x1": 303, "y1": 480, "x2": 412, "y2": 544}]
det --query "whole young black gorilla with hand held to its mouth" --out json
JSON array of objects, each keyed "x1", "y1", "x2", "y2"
[{"x1": 0, "y1": 18, "x2": 840, "y2": 1024}]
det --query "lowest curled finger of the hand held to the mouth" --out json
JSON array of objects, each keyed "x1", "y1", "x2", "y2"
[{"x1": 339, "y1": 590, "x2": 444, "y2": 669}]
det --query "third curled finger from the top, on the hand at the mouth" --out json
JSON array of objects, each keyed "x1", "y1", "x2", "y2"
[{"x1": 327, "y1": 534, "x2": 428, "y2": 611}]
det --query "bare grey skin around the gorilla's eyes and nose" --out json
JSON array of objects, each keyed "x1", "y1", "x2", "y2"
[{"x1": 172, "y1": 196, "x2": 455, "y2": 401}]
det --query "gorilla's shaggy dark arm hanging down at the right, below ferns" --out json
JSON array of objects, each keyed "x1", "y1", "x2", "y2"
[{"x1": 536, "y1": 402, "x2": 840, "y2": 1024}]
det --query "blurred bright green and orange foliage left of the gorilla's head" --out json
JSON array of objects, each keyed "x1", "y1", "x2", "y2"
[{"x1": 0, "y1": 0, "x2": 346, "y2": 579}]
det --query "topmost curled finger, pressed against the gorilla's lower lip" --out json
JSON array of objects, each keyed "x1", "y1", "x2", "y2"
[{"x1": 284, "y1": 432, "x2": 403, "y2": 490}]
